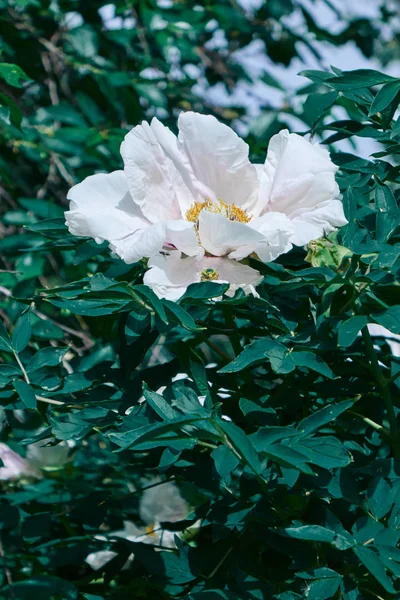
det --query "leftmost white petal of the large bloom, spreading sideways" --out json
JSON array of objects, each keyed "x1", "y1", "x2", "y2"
[{"x1": 65, "y1": 171, "x2": 148, "y2": 243}]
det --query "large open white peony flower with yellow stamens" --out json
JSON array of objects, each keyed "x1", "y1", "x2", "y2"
[{"x1": 66, "y1": 112, "x2": 347, "y2": 299}]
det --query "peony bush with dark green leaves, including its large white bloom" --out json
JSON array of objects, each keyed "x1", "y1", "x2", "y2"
[{"x1": 0, "y1": 62, "x2": 400, "y2": 600}]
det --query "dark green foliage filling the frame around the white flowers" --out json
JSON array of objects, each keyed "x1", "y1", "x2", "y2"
[{"x1": 0, "y1": 0, "x2": 400, "y2": 600}]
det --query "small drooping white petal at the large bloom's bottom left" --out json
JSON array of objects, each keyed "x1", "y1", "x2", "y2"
[{"x1": 143, "y1": 251, "x2": 200, "y2": 300}]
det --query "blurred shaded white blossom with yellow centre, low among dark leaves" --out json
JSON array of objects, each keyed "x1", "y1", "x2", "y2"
[{"x1": 86, "y1": 482, "x2": 195, "y2": 571}]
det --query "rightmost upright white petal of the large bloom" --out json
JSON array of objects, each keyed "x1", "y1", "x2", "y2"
[{"x1": 258, "y1": 130, "x2": 347, "y2": 245}]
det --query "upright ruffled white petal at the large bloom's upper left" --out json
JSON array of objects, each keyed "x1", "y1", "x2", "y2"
[{"x1": 121, "y1": 121, "x2": 193, "y2": 223}]
